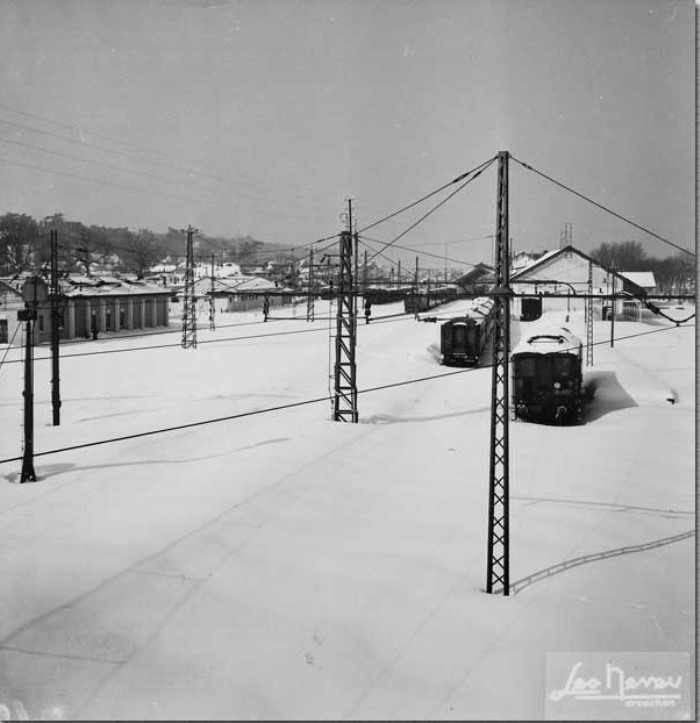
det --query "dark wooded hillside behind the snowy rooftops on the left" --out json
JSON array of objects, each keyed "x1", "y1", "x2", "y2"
[{"x1": 0, "y1": 213, "x2": 292, "y2": 278}]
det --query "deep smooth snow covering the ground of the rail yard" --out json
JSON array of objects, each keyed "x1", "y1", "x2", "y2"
[{"x1": 0, "y1": 302, "x2": 695, "y2": 720}]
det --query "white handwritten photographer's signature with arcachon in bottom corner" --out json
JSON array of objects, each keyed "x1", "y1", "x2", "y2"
[{"x1": 549, "y1": 660, "x2": 683, "y2": 707}]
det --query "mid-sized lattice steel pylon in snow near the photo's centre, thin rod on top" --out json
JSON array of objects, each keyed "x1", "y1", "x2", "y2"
[{"x1": 333, "y1": 201, "x2": 358, "y2": 422}]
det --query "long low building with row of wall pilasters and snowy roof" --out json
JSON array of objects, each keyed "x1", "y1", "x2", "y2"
[{"x1": 0, "y1": 275, "x2": 171, "y2": 345}]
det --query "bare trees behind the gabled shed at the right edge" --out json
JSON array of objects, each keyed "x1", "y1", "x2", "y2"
[{"x1": 590, "y1": 241, "x2": 695, "y2": 293}]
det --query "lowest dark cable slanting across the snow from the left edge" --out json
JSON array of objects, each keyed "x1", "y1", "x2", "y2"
[{"x1": 0, "y1": 326, "x2": 688, "y2": 464}]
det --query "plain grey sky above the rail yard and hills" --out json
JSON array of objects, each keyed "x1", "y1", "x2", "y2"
[{"x1": 0, "y1": 0, "x2": 695, "y2": 266}]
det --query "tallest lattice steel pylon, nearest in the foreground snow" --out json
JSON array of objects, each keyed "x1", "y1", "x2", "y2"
[{"x1": 486, "y1": 151, "x2": 512, "y2": 595}]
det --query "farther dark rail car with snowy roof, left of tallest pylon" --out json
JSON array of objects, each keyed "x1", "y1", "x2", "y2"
[{"x1": 440, "y1": 298, "x2": 493, "y2": 366}]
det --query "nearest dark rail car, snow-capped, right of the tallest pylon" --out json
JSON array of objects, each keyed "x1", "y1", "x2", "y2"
[{"x1": 511, "y1": 327, "x2": 584, "y2": 424}]
